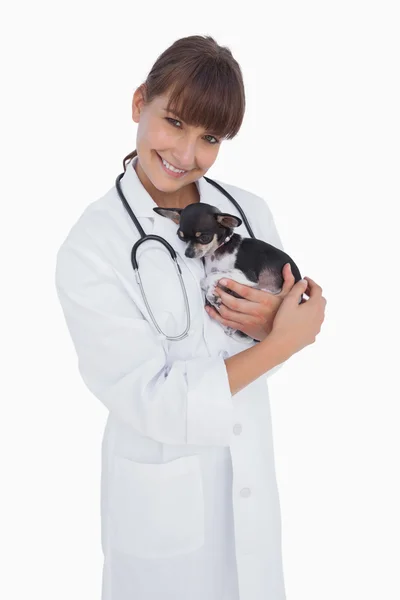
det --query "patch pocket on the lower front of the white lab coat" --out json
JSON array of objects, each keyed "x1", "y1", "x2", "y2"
[{"x1": 110, "y1": 455, "x2": 204, "y2": 559}]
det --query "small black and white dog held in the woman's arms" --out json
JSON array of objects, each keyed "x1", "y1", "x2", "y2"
[{"x1": 153, "y1": 202, "x2": 301, "y2": 341}]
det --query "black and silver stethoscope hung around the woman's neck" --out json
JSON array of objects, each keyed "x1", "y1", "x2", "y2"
[{"x1": 115, "y1": 172, "x2": 255, "y2": 341}]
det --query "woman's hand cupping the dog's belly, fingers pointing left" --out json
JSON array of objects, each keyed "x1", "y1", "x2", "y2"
[{"x1": 206, "y1": 263, "x2": 294, "y2": 342}]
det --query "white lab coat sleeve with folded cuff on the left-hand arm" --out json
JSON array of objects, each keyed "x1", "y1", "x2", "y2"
[{"x1": 55, "y1": 238, "x2": 234, "y2": 446}]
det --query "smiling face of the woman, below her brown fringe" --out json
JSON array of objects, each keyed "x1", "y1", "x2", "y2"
[{"x1": 132, "y1": 88, "x2": 222, "y2": 192}]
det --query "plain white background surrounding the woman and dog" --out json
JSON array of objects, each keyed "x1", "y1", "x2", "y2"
[{"x1": 0, "y1": 0, "x2": 400, "y2": 600}]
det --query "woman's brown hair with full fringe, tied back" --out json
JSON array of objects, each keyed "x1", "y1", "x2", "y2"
[{"x1": 123, "y1": 35, "x2": 245, "y2": 171}]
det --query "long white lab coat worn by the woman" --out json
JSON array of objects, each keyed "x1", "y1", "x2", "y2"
[{"x1": 56, "y1": 157, "x2": 285, "y2": 600}]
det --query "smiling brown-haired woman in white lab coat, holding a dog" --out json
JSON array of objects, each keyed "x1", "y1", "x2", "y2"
[{"x1": 56, "y1": 36, "x2": 326, "y2": 600}]
